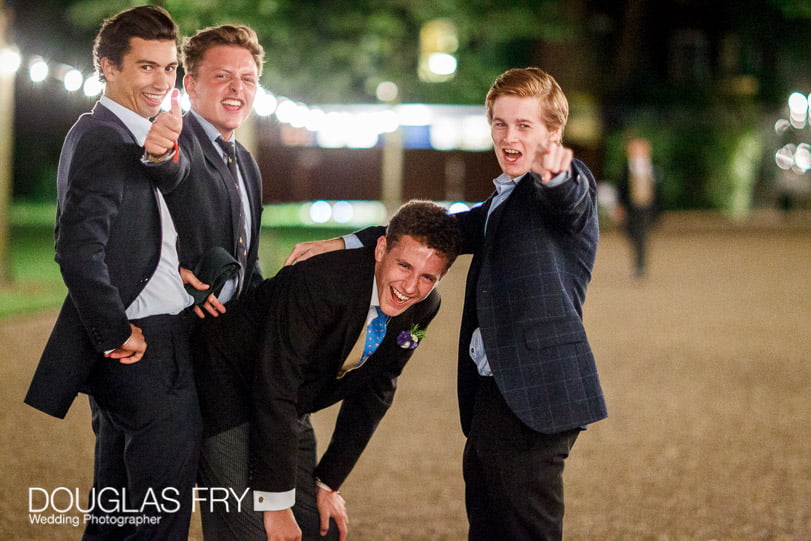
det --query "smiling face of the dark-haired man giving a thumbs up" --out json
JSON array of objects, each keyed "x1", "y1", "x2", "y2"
[{"x1": 101, "y1": 38, "x2": 177, "y2": 118}]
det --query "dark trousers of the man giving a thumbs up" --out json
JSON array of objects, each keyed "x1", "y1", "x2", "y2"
[{"x1": 84, "y1": 316, "x2": 202, "y2": 541}]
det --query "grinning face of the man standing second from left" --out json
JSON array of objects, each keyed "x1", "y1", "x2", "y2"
[{"x1": 183, "y1": 45, "x2": 259, "y2": 140}]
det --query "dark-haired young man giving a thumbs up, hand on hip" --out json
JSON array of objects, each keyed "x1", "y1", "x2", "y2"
[{"x1": 25, "y1": 6, "x2": 202, "y2": 539}]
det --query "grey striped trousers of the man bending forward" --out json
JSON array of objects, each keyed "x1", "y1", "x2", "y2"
[{"x1": 197, "y1": 415, "x2": 338, "y2": 541}]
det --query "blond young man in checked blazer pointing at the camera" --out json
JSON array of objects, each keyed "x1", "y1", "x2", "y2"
[{"x1": 288, "y1": 68, "x2": 607, "y2": 541}]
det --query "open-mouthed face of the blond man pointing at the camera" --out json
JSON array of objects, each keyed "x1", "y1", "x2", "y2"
[{"x1": 490, "y1": 96, "x2": 560, "y2": 178}]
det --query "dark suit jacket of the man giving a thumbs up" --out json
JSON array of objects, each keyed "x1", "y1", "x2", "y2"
[{"x1": 25, "y1": 104, "x2": 189, "y2": 417}]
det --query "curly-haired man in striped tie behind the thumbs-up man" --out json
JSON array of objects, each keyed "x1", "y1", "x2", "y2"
[{"x1": 166, "y1": 25, "x2": 264, "y2": 318}]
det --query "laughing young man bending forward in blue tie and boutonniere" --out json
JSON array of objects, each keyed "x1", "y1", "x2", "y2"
[{"x1": 195, "y1": 201, "x2": 461, "y2": 540}]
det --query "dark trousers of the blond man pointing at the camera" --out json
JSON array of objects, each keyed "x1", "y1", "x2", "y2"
[{"x1": 463, "y1": 377, "x2": 580, "y2": 541}]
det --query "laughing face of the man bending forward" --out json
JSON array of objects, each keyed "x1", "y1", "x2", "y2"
[{"x1": 375, "y1": 235, "x2": 448, "y2": 316}]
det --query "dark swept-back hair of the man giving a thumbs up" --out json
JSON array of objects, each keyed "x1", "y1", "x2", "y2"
[{"x1": 93, "y1": 6, "x2": 178, "y2": 81}]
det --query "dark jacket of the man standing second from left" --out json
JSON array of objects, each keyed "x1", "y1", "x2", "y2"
[{"x1": 166, "y1": 114, "x2": 262, "y2": 289}]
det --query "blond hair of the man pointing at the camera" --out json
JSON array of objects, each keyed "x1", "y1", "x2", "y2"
[{"x1": 484, "y1": 68, "x2": 569, "y2": 142}]
